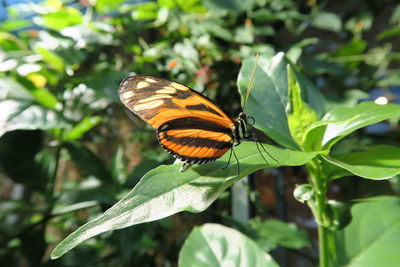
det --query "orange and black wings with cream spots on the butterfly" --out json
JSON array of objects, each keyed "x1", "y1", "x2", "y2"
[{"x1": 119, "y1": 75, "x2": 235, "y2": 164}]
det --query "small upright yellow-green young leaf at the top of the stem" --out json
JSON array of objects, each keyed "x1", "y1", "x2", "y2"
[{"x1": 286, "y1": 65, "x2": 317, "y2": 146}]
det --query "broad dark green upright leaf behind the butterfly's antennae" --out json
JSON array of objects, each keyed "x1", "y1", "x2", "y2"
[{"x1": 237, "y1": 53, "x2": 324, "y2": 149}]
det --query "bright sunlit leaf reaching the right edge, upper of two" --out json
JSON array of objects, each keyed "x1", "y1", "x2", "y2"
[{"x1": 304, "y1": 102, "x2": 400, "y2": 150}]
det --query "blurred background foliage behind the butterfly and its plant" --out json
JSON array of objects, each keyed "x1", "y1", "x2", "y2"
[{"x1": 0, "y1": 0, "x2": 400, "y2": 266}]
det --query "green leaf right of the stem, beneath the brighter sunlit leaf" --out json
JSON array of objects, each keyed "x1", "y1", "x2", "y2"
[{"x1": 323, "y1": 145, "x2": 400, "y2": 180}]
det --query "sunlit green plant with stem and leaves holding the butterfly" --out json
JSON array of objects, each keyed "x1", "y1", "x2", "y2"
[{"x1": 52, "y1": 53, "x2": 400, "y2": 266}]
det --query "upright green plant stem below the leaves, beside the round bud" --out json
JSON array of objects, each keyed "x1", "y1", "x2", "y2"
[{"x1": 307, "y1": 159, "x2": 331, "y2": 267}]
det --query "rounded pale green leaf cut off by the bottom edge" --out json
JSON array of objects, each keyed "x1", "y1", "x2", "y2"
[{"x1": 178, "y1": 223, "x2": 279, "y2": 267}]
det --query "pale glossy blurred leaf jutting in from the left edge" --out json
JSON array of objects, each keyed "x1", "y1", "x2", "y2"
[{"x1": 0, "y1": 100, "x2": 68, "y2": 136}]
